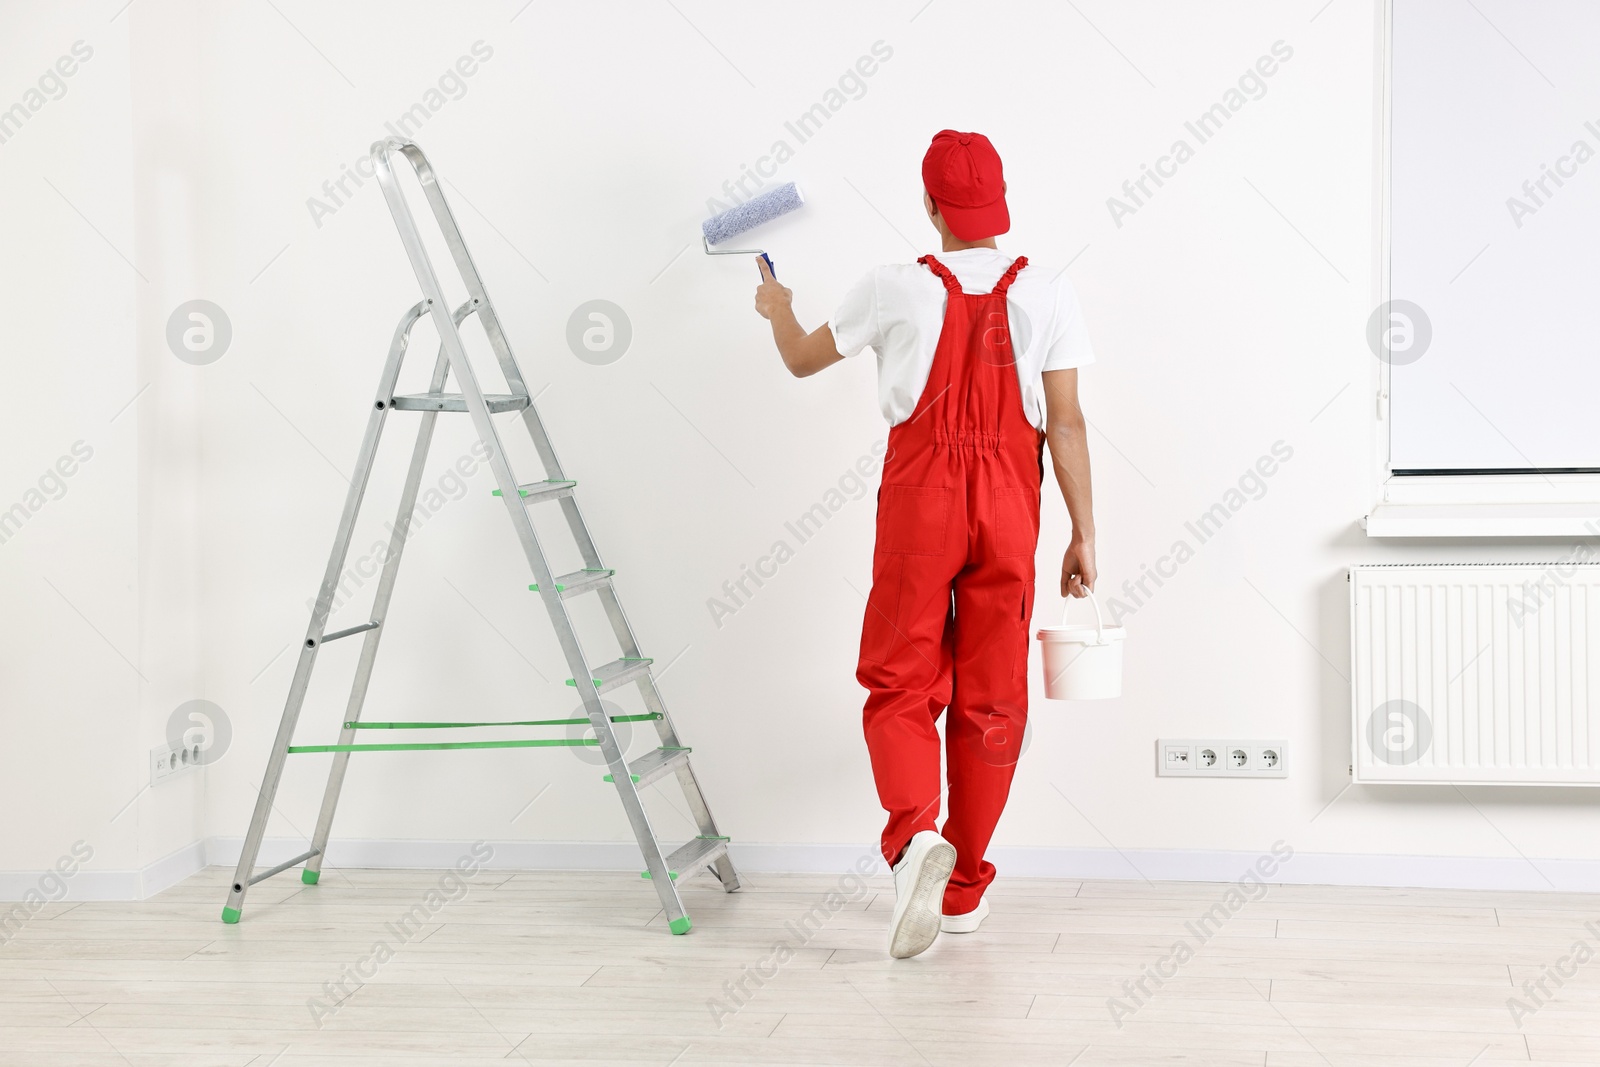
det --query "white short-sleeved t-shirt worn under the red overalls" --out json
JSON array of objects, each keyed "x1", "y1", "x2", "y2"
[{"x1": 829, "y1": 248, "x2": 1094, "y2": 429}]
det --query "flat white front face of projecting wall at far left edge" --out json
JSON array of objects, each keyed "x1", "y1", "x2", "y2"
[{"x1": 0, "y1": 5, "x2": 147, "y2": 869}]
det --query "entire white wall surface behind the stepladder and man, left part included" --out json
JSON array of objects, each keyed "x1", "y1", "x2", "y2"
[{"x1": 0, "y1": 0, "x2": 1600, "y2": 885}]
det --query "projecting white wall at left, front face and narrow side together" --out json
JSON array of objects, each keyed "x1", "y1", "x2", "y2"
[{"x1": 0, "y1": 3, "x2": 214, "y2": 893}]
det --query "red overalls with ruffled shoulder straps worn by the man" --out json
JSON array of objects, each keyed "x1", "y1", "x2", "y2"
[{"x1": 856, "y1": 256, "x2": 1045, "y2": 915}]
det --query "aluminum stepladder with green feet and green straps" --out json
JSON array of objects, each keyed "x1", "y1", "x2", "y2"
[{"x1": 222, "y1": 139, "x2": 739, "y2": 934}]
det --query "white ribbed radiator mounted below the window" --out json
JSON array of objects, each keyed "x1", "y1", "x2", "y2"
[{"x1": 1349, "y1": 563, "x2": 1600, "y2": 785}]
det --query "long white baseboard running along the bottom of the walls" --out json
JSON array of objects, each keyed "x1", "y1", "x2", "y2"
[{"x1": 12, "y1": 837, "x2": 1600, "y2": 901}]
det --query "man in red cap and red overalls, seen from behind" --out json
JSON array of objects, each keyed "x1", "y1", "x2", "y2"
[{"x1": 755, "y1": 130, "x2": 1094, "y2": 958}]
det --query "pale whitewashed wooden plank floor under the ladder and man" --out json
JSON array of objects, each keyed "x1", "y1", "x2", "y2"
[{"x1": 0, "y1": 869, "x2": 1600, "y2": 1067}]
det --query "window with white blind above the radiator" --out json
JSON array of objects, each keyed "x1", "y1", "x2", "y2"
[{"x1": 1368, "y1": 0, "x2": 1600, "y2": 533}]
